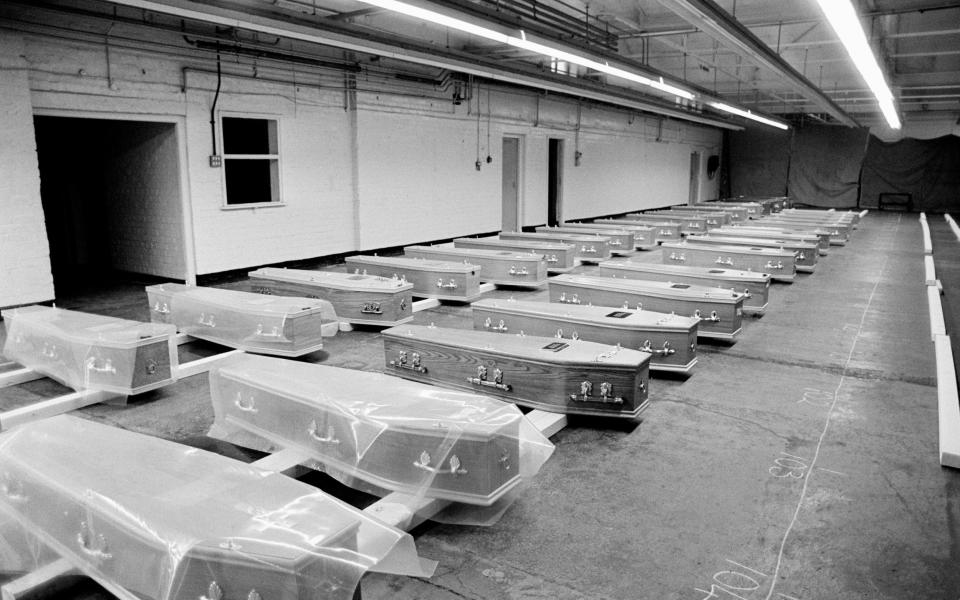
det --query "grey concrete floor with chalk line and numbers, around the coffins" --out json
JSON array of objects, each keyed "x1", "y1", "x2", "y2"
[{"x1": 0, "y1": 212, "x2": 960, "y2": 600}]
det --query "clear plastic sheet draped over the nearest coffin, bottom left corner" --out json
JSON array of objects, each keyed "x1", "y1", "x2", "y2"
[{"x1": 0, "y1": 416, "x2": 424, "y2": 600}]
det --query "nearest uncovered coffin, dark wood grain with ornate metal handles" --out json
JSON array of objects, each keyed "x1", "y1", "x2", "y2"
[{"x1": 383, "y1": 325, "x2": 650, "y2": 418}]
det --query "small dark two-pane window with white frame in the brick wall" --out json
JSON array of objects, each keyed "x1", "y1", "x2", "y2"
[{"x1": 220, "y1": 117, "x2": 280, "y2": 206}]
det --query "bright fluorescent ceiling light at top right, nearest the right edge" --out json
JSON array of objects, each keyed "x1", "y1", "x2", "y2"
[{"x1": 817, "y1": 0, "x2": 900, "y2": 129}]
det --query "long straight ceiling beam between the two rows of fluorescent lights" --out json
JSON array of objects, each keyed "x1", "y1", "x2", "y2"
[{"x1": 659, "y1": 0, "x2": 860, "y2": 127}]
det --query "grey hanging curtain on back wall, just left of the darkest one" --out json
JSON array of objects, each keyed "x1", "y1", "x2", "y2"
[{"x1": 787, "y1": 124, "x2": 869, "y2": 208}]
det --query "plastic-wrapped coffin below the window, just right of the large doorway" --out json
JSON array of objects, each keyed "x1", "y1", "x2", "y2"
[{"x1": 146, "y1": 283, "x2": 340, "y2": 356}]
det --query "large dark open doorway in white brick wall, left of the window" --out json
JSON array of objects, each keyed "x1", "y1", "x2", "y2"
[{"x1": 34, "y1": 116, "x2": 186, "y2": 298}]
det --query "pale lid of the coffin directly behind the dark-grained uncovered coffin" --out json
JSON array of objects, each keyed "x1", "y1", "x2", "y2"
[{"x1": 471, "y1": 298, "x2": 699, "y2": 333}]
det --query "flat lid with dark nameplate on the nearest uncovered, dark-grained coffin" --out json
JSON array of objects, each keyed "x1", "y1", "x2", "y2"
[{"x1": 383, "y1": 325, "x2": 650, "y2": 369}]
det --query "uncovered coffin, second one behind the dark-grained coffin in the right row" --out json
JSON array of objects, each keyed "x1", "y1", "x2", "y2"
[{"x1": 550, "y1": 275, "x2": 744, "y2": 340}]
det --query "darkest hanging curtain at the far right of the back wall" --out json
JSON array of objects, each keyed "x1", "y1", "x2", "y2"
[{"x1": 860, "y1": 135, "x2": 960, "y2": 212}]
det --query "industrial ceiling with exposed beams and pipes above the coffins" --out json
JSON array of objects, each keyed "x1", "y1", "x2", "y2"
[{"x1": 9, "y1": 0, "x2": 960, "y2": 128}]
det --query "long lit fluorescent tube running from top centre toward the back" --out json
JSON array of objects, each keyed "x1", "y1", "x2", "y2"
[{"x1": 360, "y1": 0, "x2": 694, "y2": 100}]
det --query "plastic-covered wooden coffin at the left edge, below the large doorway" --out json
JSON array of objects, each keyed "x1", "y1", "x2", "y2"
[{"x1": 0, "y1": 306, "x2": 177, "y2": 395}]
